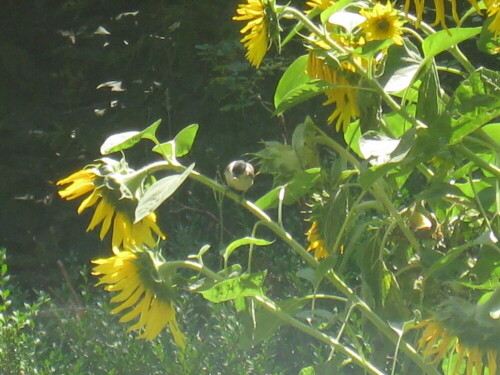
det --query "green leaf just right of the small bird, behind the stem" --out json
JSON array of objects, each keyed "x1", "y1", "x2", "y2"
[{"x1": 255, "y1": 168, "x2": 321, "y2": 210}]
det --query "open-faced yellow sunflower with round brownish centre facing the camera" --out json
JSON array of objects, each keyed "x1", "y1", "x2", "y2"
[{"x1": 360, "y1": 2, "x2": 403, "y2": 45}]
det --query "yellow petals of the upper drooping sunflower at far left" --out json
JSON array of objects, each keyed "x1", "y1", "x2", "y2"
[{"x1": 57, "y1": 167, "x2": 166, "y2": 249}]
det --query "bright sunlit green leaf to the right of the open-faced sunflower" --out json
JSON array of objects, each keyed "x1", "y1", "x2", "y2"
[{"x1": 422, "y1": 27, "x2": 481, "y2": 59}]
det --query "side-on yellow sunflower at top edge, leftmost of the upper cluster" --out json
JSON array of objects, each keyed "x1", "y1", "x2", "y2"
[{"x1": 233, "y1": 0, "x2": 269, "y2": 68}]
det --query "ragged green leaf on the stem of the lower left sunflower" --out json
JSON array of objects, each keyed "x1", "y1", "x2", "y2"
[{"x1": 199, "y1": 271, "x2": 267, "y2": 303}]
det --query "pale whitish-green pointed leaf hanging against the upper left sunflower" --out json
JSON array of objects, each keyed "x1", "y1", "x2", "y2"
[{"x1": 134, "y1": 164, "x2": 194, "y2": 223}]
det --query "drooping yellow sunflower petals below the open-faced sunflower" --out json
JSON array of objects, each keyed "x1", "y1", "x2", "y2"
[{"x1": 307, "y1": 50, "x2": 360, "y2": 131}]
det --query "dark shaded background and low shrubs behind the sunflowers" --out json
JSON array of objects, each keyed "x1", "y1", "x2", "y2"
[{"x1": 0, "y1": 0, "x2": 312, "y2": 375}]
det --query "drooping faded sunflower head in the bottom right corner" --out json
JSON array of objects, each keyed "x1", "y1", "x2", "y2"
[{"x1": 415, "y1": 299, "x2": 500, "y2": 375}]
